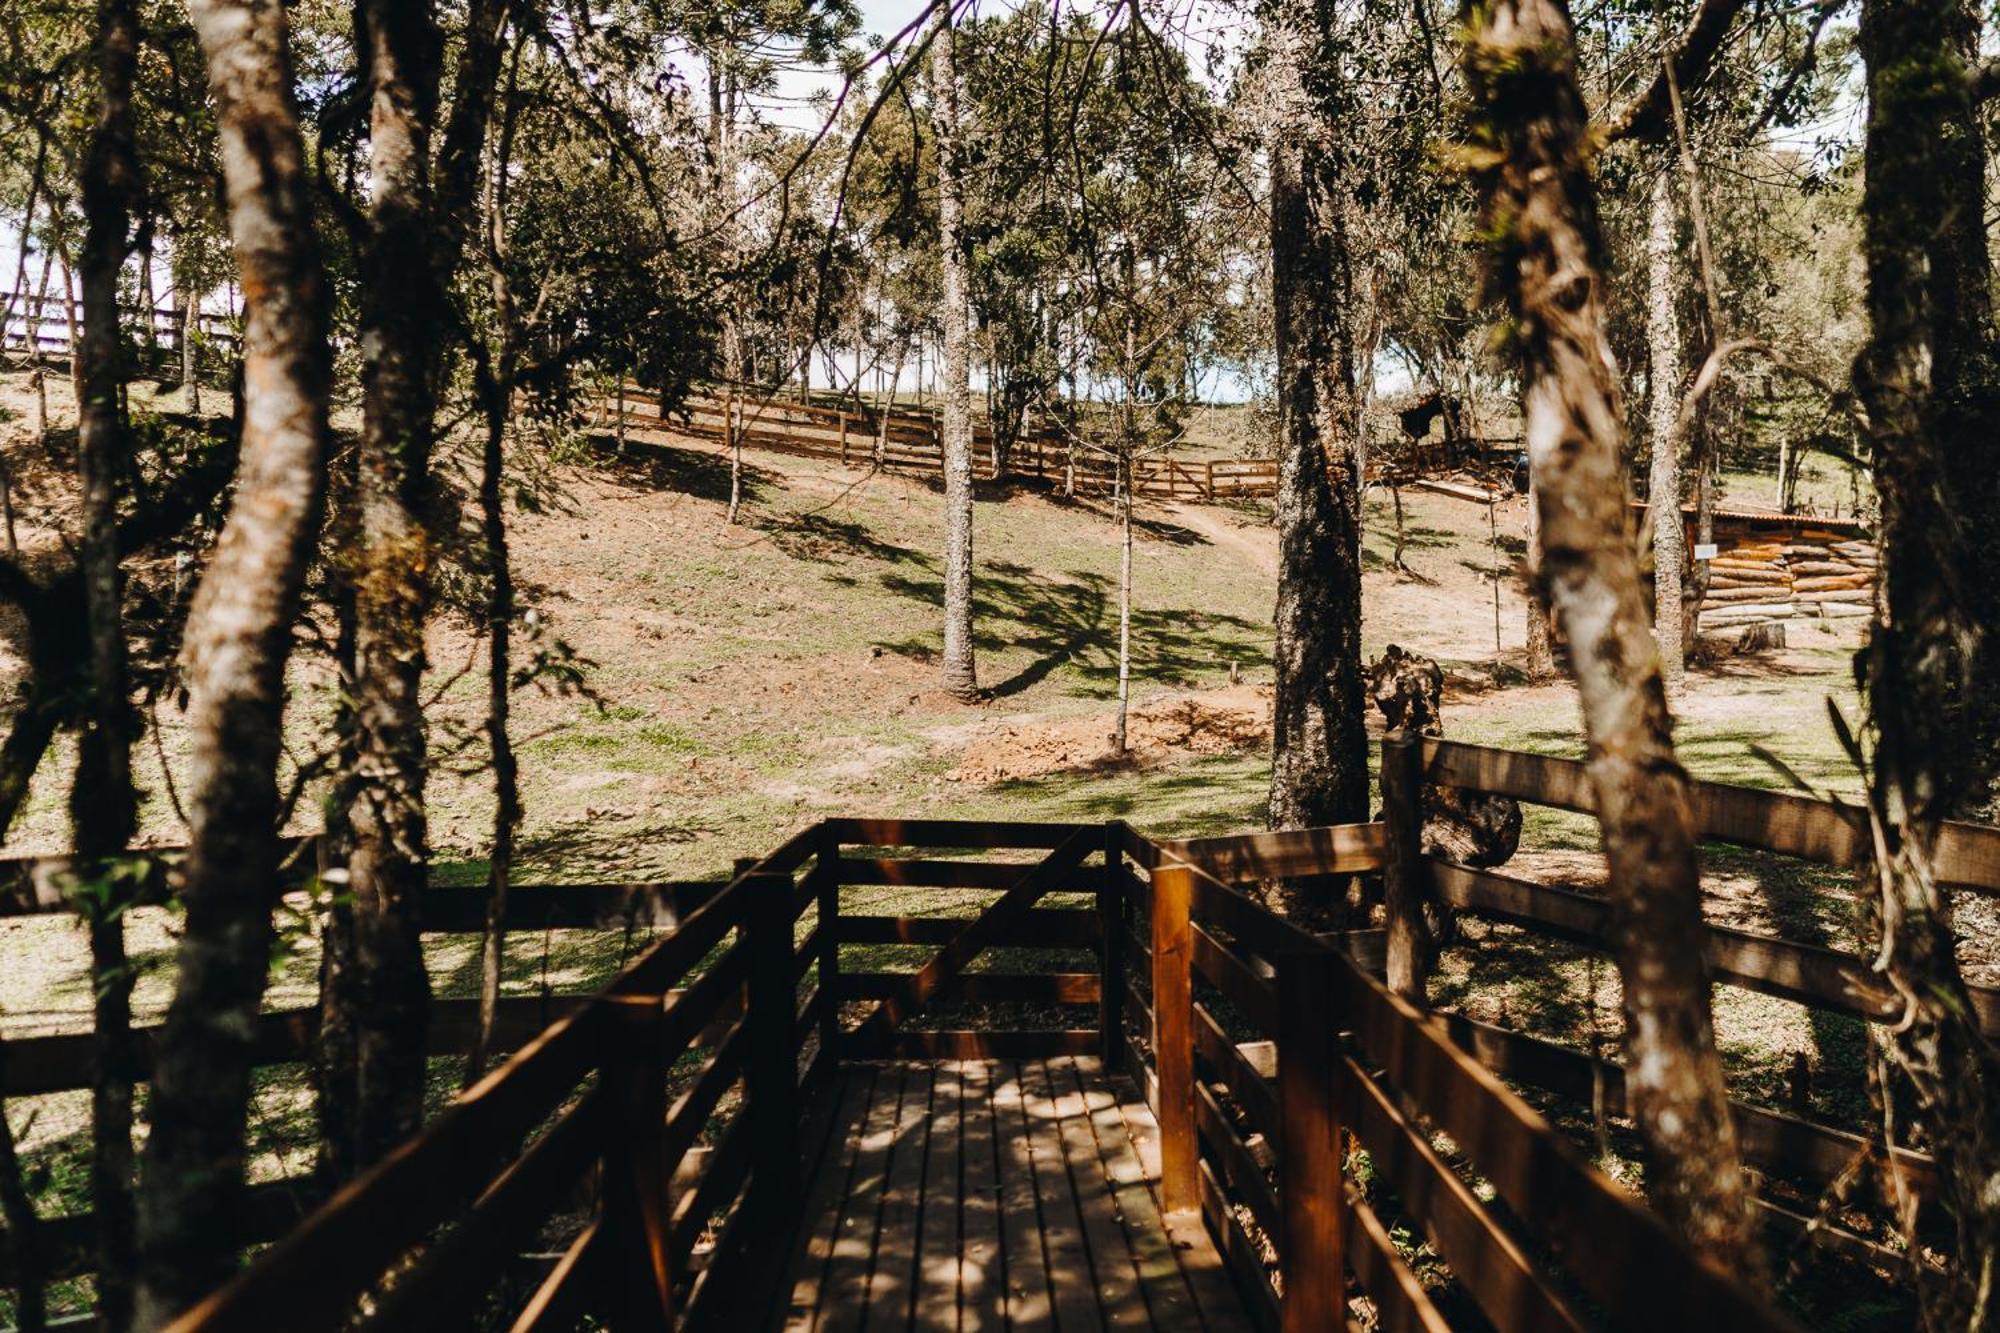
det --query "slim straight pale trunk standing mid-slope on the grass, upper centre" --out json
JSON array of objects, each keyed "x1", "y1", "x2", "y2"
[{"x1": 930, "y1": 4, "x2": 980, "y2": 703}]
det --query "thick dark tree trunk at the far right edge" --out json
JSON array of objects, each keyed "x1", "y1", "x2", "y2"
[{"x1": 1854, "y1": 0, "x2": 2000, "y2": 1329}]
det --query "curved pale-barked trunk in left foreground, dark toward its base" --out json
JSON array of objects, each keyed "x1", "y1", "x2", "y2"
[{"x1": 138, "y1": 0, "x2": 330, "y2": 1304}]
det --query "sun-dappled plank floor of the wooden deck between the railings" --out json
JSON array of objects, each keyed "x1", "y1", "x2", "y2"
[{"x1": 780, "y1": 1057, "x2": 1250, "y2": 1331}]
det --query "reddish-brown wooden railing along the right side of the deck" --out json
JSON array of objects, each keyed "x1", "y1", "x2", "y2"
[{"x1": 1114, "y1": 825, "x2": 1786, "y2": 1329}]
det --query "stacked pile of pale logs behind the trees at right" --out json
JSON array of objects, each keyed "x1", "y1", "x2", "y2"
[{"x1": 1702, "y1": 528, "x2": 1876, "y2": 628}]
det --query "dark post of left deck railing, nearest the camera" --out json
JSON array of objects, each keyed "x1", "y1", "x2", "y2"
[{"x1": 602, "y1": 995, "x2": 674, "y2": 1333}]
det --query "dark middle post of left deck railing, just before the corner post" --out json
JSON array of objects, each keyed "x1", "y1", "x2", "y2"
[{"x1": 744, "y1": 875, "x2": 798, "y2": 1211}]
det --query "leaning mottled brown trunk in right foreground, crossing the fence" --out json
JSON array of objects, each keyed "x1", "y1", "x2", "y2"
[{"x1": 1464, "y1": 0, "x2": 1756, "y2": 1271}]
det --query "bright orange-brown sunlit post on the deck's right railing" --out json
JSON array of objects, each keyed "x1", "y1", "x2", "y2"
[{"x1": 1152, "y1": 865, "x2": 1202, "y2": 1213}]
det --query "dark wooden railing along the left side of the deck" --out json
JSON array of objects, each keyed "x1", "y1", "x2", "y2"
[{"x1": 152, "y1": 827, "x2": 832, "y2": 1331}]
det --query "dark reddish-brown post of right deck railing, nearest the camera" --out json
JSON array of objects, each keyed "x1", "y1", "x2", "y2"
[{"x1": 1278, "y1": 951, "x2": 1348, "y2": 1333}]
